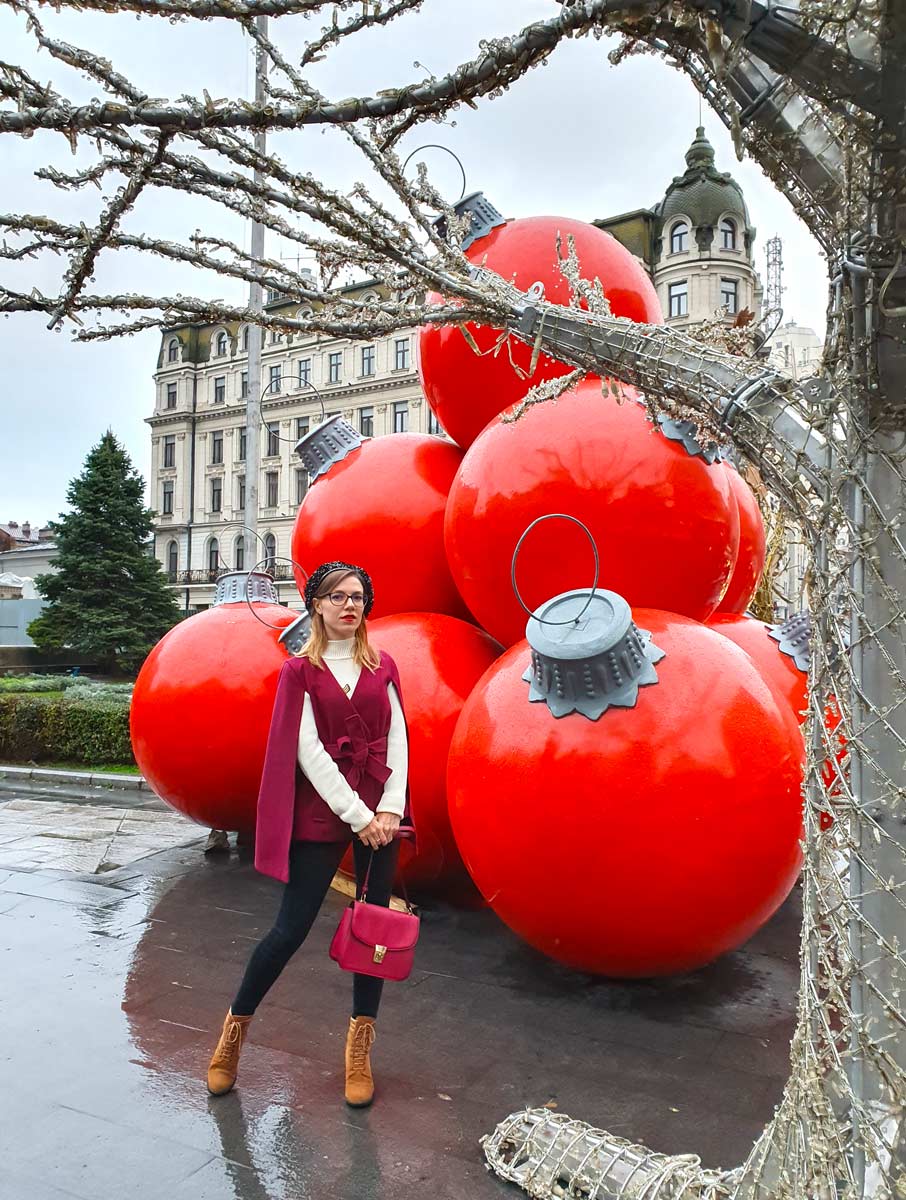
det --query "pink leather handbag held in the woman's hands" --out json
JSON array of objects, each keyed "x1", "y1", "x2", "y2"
[{"x1": 330, "y1": 851, "x2": 419, "y2": 979}]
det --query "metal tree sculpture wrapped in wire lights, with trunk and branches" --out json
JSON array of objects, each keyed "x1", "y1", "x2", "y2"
[{"x1": 0, "y1": 0, "x2": 906, "y2": 1200}]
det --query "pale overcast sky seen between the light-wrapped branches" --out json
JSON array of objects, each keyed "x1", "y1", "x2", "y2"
[{"x1": 0, "y1": 0, "x2": 826, "y2": 524}]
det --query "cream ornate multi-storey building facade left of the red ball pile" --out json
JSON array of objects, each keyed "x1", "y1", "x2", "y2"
[{"x1": 148, "y1": 284, "x2": 443, "y2": 612}]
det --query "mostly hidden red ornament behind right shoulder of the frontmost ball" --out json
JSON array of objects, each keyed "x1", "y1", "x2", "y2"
[{"x1": 708, "y1": 612, "x2": 811, "y2": 722}]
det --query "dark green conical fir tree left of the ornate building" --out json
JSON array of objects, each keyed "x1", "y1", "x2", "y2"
[{"x1": 29, "y1": 430, "x2": 180, "y2": 672}]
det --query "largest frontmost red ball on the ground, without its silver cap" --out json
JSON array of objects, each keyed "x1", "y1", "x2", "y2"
[{"x1": 448, "y1": 610, "x2": 804, "y2": 978}]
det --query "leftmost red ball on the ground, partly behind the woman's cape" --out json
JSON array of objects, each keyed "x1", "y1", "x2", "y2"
[{"x1": 130, "y1": 601, "x2": 298, "y2": 830}]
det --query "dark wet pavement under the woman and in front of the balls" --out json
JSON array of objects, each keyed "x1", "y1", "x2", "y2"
[{"x1": 0, "y1": 787, "x2": 799, "y2": 1200}]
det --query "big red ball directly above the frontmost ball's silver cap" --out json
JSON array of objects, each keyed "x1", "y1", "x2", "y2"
[{"x1": 444, "y1": 379, "x2": 739, "y2": 646}]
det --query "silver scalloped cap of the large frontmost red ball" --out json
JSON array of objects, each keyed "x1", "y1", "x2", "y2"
[{"x1": 522, "y1": 588, "x2": 666, "y2": 721}]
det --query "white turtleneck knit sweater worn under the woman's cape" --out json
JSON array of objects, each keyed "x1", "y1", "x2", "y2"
[{"x1": 299, "y1": 637, "x2": 409, "y2": 833}]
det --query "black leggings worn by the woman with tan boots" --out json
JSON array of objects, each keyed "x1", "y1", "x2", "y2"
[{"x1": 232, "y1": 838, "x2": 400, "y2": 1016}]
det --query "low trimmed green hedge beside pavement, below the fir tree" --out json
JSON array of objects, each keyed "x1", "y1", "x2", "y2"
[{"x1": 0, "y1": 689, "x2": 134, "y2": 766}]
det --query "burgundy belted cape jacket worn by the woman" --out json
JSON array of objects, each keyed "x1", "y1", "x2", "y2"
[{"x1": 254, "y1": 650, "x2": 414, "y2": 883}]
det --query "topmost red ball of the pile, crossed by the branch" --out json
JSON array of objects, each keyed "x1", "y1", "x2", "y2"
[{"x1": 419, "y1": 217, "x2": 664, "y2": 446}]
